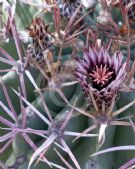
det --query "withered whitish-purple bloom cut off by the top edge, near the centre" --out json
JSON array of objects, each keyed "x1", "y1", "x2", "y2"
[{"x1": 55, "y1": 0, "x2": 82, "y2": 20}]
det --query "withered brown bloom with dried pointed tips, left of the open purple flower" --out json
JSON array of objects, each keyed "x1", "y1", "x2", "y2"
[{"x1": 27, "y1": 18, "x2": 54, "y2": 67}]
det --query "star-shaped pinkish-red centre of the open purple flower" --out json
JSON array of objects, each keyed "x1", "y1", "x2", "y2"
[{"x1": 89, "y1": 64, "x2": 114, "y2": 88}]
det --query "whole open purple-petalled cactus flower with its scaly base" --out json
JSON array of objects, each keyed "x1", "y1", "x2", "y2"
[{"x1": 75, "y1": 47, "x2": 126, "y2": 108}]
